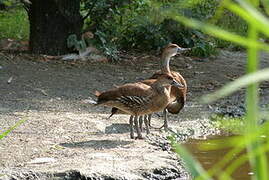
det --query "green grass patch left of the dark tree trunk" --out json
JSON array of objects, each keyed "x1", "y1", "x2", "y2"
[{"x1": 0, "y1": 8, "x2": 29, "y2": 40}]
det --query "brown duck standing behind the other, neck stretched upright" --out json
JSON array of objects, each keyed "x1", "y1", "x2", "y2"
[{"x1": 109, "y1": 44, "x2": 189, "y2": 133}]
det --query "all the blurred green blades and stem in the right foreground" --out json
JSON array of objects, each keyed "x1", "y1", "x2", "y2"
[{"x1": 168, "y1": 0, "x2": 269, "y2": 180}]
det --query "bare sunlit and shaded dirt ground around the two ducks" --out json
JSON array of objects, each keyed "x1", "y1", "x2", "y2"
[{"x1": 0, "y1": 51, "x2": 269, "y2": 179}]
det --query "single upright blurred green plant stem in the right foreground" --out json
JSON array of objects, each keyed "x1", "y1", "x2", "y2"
[{"x1": 245, "y1": 0, "x2": 267, "y2": 176}]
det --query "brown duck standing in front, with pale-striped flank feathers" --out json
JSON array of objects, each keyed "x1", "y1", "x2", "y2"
[{"x1": 95, "y1": 74, "x2": 184, "y2": 139}]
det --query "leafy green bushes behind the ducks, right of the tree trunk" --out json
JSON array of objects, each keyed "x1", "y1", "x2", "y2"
[{"x1": 82, "y1": 0, "x2": 222, "y2": 56}]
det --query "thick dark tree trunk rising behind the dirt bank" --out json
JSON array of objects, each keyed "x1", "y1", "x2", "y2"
[{"x1": 28, "y1": 0, "x2": 83, "y2": 55}]
